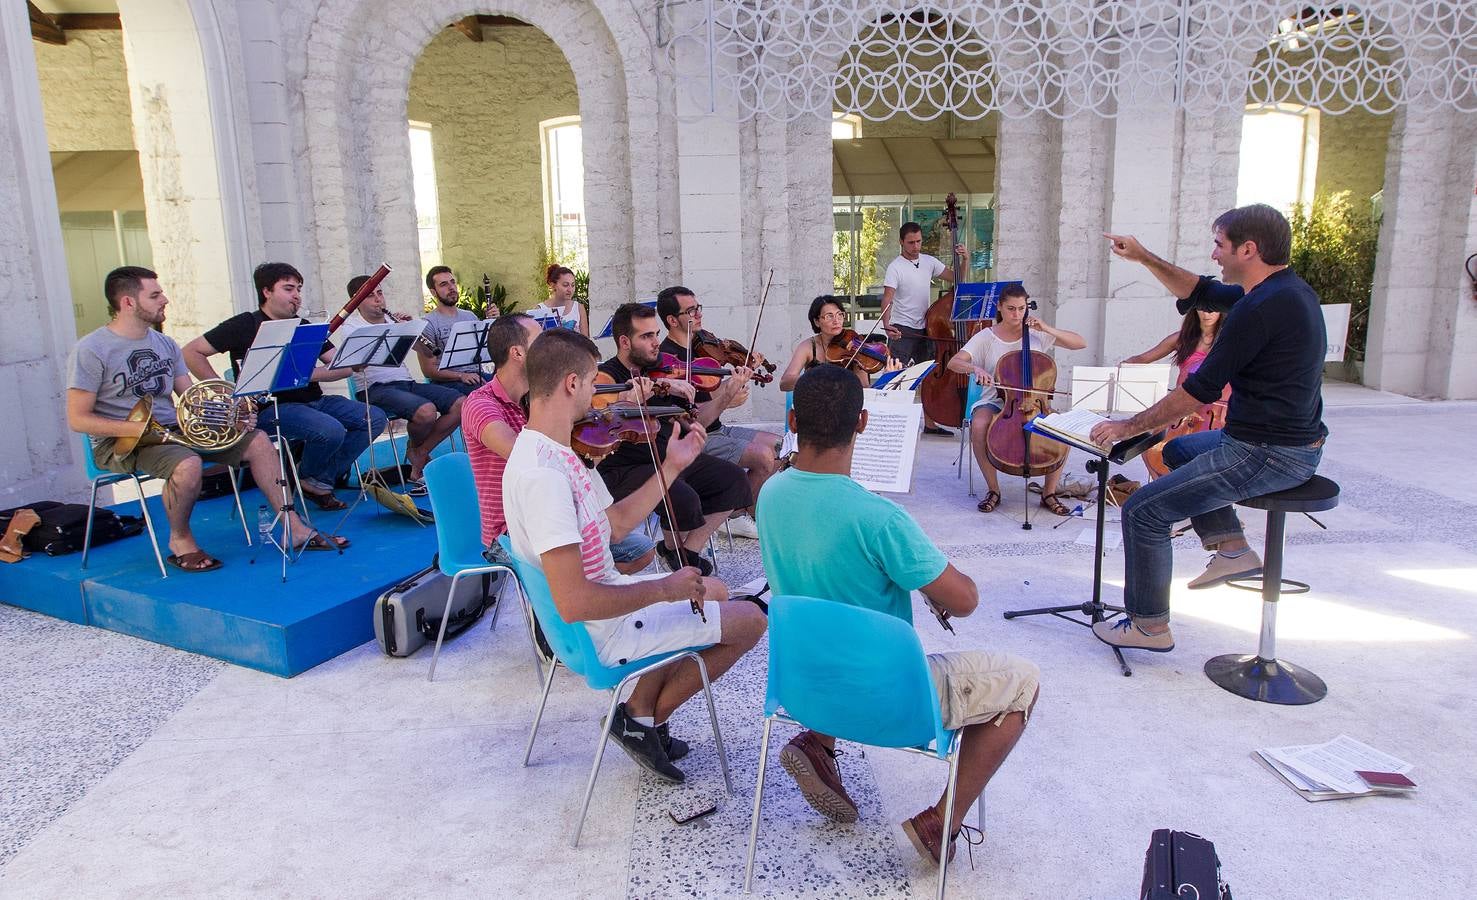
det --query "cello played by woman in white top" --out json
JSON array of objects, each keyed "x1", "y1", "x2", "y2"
[{"x1": 985, "y1": 300, "x2": 1071, "y2": 531}]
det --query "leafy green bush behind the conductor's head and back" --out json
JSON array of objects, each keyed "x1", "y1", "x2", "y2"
[{"x1": 1289, "y1": 191, "x2": 1380, "y2": 359}]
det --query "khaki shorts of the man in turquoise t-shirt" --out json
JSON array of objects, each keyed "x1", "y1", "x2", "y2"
[{"x1": 928, "y1": 650, "x2": 1041, "y2": 730}]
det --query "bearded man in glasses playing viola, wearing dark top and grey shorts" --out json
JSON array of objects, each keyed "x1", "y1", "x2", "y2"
[{"x1": 656, "y1": 285, "x2": 783, "y2": 538}]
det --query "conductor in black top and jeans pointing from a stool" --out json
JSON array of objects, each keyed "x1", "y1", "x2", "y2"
[{"x1": 1092, "y1": 204, "x2": 1328, "y2": 652}]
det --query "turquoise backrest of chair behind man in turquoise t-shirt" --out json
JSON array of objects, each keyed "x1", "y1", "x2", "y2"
[{"x1": 764, "y1": 596, "x2": 950, "y2": 757}]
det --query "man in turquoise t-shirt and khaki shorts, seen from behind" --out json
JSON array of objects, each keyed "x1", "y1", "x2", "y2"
[{"x1": 755, "y1": 365, "x2": 1040, "y2": 862}]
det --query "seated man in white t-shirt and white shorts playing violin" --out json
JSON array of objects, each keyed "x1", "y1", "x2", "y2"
[{"x1": 502, "y1": 328, "x2": 767, "y2": 783}]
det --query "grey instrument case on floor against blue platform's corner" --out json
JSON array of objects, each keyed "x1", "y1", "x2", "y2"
[{"x1": 374, "y1": 565, "x2": 498, "y2": 656}]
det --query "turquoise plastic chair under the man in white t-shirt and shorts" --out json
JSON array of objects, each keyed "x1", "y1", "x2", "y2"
[{"x1": 498, "y1": 535, "x2": 734, "y2": 847}]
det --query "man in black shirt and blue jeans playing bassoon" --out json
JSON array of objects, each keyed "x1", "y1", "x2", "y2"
[{"x1": 185, "y1": 263, "x2": 385, "y2": 510}]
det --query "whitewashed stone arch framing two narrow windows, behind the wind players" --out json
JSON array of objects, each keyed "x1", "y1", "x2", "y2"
[{"x1": 303, "y1": 0, "x2": 654, "y2": 317}]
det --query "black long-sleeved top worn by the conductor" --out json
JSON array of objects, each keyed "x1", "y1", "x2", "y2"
[{"x1": 1179, "y1": 269, "x2": 1328, "y2": 446}]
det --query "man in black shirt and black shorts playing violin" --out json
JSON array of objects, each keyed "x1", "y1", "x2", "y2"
[{"x1": 598, "y1": 303, "x2": 753, "y2": 575}]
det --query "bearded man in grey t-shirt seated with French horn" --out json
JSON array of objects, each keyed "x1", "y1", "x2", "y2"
[{"x1": 66, "y1": 266, "x2": 334, "y2": 572}]
